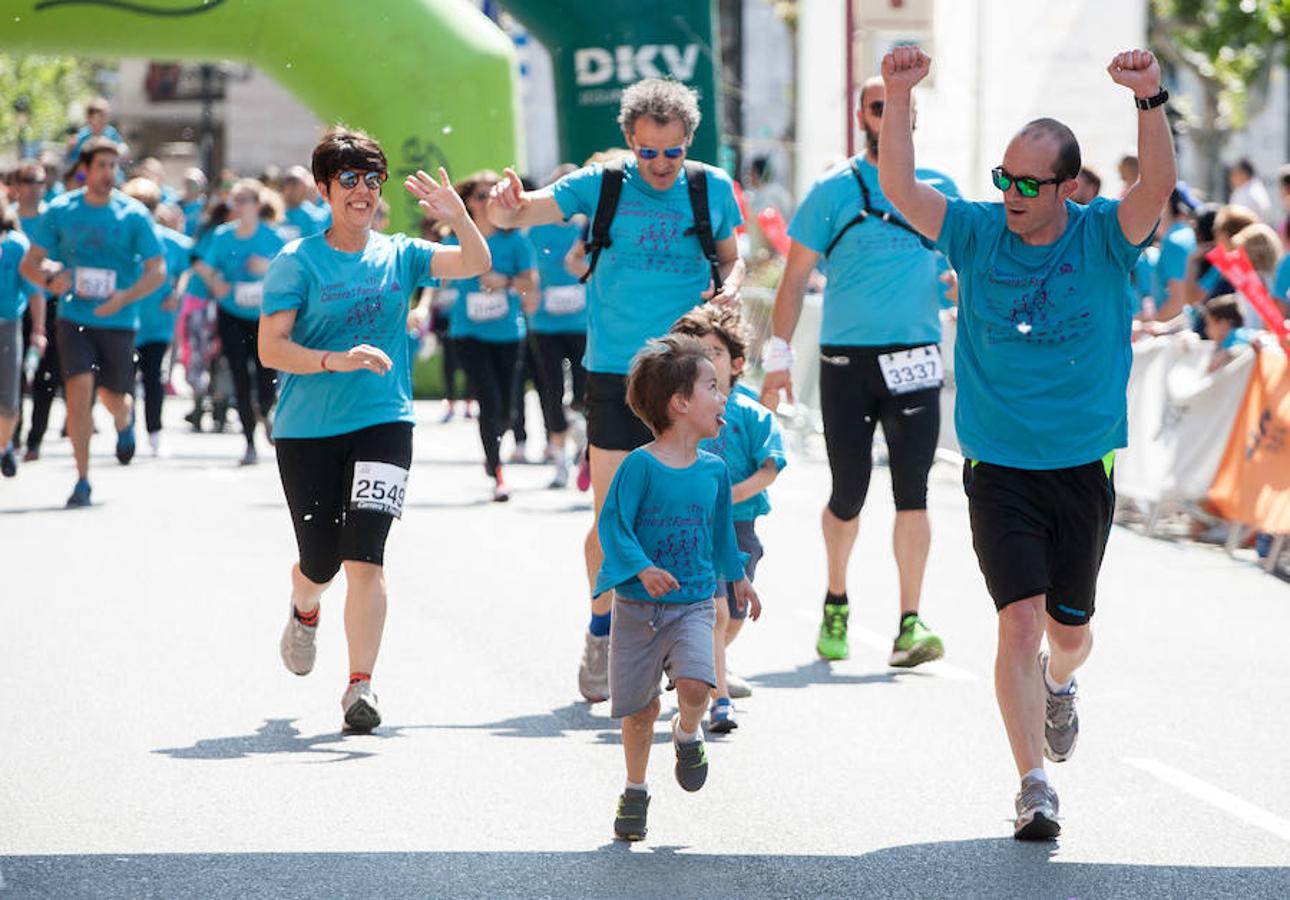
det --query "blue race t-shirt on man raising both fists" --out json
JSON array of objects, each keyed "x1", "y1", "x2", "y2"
[{"x1": 937, "y1": 197, "x2": 1149, "y2": 469}]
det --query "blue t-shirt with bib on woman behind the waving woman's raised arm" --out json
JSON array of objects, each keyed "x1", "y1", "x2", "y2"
[{"x1": 444, "y1": 231, "x2": 533, "y2": 343}]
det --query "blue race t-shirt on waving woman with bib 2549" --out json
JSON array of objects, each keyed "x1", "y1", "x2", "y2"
[{"x1": 264, "y1": 232, "x2": 435, "y2": 437}]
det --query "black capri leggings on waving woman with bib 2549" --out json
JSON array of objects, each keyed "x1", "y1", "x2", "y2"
[{"x1": 277, "y1": 422, "x2": 412, "y2": 584}]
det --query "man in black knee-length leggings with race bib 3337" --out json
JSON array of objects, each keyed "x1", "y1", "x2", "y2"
[{"x1": 761, "y1": 77, "x2": 958, "y2": 668}]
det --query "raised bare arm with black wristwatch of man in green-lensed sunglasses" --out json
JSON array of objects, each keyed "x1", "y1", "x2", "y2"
[{"x1": 1107, "y1": 50, "x2": 1178, "y2": 244}]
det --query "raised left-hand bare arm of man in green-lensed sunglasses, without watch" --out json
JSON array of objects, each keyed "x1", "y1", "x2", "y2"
[{"x1": 878, "y1": 46, "x2": 947, "y2": 241}]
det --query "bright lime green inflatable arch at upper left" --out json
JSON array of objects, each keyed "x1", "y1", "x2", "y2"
[{"x1": 0, "y1": 0, "x2": 522, "y2": 231}]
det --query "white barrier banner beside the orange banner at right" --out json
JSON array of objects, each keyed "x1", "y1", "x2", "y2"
[{"x1": 1116, "y1": 335, "x2": 1254, "y2": 503}]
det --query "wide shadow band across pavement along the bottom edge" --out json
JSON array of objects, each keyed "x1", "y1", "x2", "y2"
[{"x1": 0, "y1": 838, "x2": 1290, "y2": 900}]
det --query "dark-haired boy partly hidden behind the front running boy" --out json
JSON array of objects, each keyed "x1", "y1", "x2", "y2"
[{"x1": 672, "y1": 303, "x2": 786, "y2": 734}]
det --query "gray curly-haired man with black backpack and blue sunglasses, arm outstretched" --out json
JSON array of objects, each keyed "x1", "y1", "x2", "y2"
[{"x1": 488, "y1": 79, "x2": 744, "y2": 703}]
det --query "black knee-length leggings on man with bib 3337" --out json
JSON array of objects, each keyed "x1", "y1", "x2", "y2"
[{"x1": 819, "y1": 344, "x2": 940, "y2": 522}]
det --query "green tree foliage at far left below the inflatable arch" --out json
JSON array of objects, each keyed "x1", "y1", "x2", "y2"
[{"x1": 0, "y1": 54, "x2": 101, "y2": 153}]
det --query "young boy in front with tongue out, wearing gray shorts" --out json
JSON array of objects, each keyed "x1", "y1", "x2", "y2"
[{"x1": 595, "y1": 334, "x2": 761, "y2": 841}]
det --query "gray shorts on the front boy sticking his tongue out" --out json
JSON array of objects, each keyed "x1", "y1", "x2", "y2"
[{"x1": 609, "y1": 597, "x2": 717, "y2": 718}]
